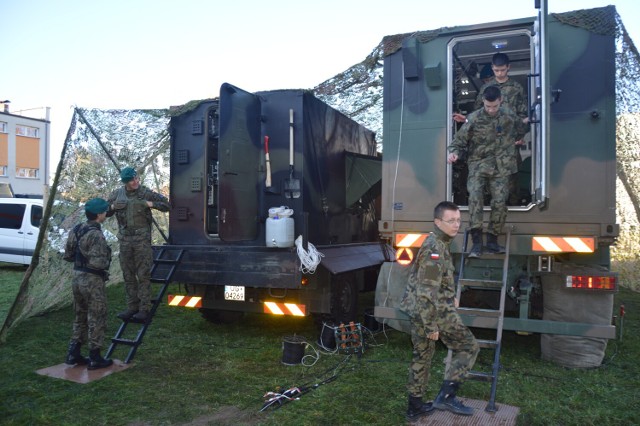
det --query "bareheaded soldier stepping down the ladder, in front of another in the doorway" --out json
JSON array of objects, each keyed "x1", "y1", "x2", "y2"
[{"x1": 447, "y1": 86, "x2": 528, "y2": 257}]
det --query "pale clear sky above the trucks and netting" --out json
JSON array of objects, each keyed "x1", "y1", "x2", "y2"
[{"x1": 0, "y1": 0, "x2": 640, "y2": 176}]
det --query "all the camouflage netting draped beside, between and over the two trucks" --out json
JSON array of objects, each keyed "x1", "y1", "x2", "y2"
[{"x1": 0, "y1": 7, "x2": 640, "y2": 341}]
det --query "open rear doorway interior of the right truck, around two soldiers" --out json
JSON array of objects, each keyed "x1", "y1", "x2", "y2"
[{"x1": 449, "y1": 30, "x2": 534, "y2": 209}]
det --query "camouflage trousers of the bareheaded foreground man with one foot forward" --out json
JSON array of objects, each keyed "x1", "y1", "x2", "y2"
[{"x1": 407, "y1": 303, "x2": 480, "y2": 397}]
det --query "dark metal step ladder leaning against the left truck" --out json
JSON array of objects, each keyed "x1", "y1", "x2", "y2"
[{"x1": 105, "y1": 246, "x2": 184, "y2": 364}]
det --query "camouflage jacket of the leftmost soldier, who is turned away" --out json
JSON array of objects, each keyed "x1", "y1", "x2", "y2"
[{"x1": 65, "y1": 220, "x2": 111, "y2": 275}]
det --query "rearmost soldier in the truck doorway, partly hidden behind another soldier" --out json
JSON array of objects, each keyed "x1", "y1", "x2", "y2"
[{"x1": 453, "y1": 52, "x2": 528, "y2": 209}]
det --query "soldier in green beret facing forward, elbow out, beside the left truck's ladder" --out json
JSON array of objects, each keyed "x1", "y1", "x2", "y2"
[{"x1": 107, "y1": 167, "x2": 170, "y2": 321}]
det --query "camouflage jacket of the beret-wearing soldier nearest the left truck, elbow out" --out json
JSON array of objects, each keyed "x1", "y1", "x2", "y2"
[{"x1": 107, "y1": 186, "x2": 171, "y2": 238}]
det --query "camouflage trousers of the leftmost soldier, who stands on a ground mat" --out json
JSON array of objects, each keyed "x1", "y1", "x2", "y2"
[{"x1": 71, "y1": 271, "x2": 107, "y2": 349}]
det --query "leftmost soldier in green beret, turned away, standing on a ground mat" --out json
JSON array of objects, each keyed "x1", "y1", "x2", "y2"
[{"x1": 65, "y1": 198, "x2": 113, "y2": 370}]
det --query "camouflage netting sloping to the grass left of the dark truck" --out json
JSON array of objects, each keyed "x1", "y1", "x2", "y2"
[{"x1": 0, "y1": 108, "x2": 169, "y2": 341}]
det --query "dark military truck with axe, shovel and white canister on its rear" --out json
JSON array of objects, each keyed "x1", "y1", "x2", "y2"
[{"x1": 162, "y1": 83, "x2": 392, "y2": 322}]
